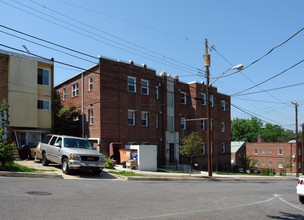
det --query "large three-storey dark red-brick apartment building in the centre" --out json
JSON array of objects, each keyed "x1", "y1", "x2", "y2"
[{"x1": 55, "y1": 58, "x2": 231, "y2": 170}]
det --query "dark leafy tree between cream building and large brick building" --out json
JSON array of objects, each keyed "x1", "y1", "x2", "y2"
[{"x1": 52, "y1": 92, "x2": 80, "y2": 136}]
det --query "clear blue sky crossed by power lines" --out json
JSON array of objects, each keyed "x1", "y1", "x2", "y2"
[{"x1": 0, "y1": 0, "x2": 304, "y2": 131}]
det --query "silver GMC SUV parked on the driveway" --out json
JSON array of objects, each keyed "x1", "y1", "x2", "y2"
[{"x1": 40, "y1": 135, "x2": 105, "y2": 175}]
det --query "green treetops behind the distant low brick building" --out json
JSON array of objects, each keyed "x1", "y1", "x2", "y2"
[{"x1": 231, "y1": 118, "x2": 295, "y2": 142}]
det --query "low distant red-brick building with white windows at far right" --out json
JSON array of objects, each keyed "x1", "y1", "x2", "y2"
[{"x1": 246, "y1": 136, "x2": 302, "y2": 173}]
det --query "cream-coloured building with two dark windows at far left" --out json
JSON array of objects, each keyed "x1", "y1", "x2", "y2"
[{"x1": 0, "y1": 50, "x2": 54, "y2": 147}]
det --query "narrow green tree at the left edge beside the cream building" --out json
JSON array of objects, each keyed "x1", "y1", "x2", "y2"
[{"x1": 0, "y1": 99, "x2": 14, "y2": 168}]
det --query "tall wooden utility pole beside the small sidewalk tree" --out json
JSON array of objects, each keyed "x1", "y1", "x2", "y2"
[{"x1": 204, "y1": 38, "x2": 212, "y2": 177}]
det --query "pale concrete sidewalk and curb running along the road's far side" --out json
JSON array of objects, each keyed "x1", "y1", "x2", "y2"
[{"x1": 0, "y1": 160, "x2": 297, "y2": 181}]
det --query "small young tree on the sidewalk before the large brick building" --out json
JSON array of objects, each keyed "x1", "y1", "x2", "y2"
[{"x1": 179, "y1": 132, "x2": 203, "y2": 175}]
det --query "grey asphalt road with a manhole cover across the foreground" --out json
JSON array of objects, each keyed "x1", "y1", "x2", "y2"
[{"x1": 0, "y1": 177, "x2": 304, "y2": 220}]
